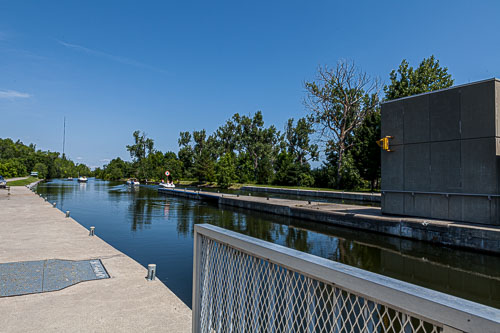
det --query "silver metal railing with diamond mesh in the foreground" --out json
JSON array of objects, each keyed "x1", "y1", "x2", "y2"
[{"x1": 193, "y1": 224, "x2": 500, "y2": 333}]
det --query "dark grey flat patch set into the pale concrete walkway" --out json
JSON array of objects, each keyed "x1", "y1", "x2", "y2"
[{"x1": 0, "y1": 259, "x2": 109, "y2": 297}]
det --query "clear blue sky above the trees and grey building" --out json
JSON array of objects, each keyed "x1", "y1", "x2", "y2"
[{"x1": 0, "y1": 0, "x2": 500, "y2": 166}]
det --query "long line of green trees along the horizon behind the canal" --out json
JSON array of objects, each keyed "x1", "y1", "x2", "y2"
[{"x1": 0, "y1": 56, "x2": 454, "y2": 190}]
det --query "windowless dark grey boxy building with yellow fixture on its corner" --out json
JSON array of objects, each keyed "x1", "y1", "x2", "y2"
[{"x1": 381, "y1": 79, "x2": 500, "y2": 225}]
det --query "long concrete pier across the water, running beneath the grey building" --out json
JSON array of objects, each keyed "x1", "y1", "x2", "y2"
[{"x1": 159, "y1": 189, "x2": 500, "y2": 253}]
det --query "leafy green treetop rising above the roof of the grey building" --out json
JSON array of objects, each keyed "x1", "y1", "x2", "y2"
[{"x1": 384, "y1": 55, "x2": 454, "y2": 100}]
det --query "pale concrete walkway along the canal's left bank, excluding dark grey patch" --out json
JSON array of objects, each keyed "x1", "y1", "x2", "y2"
[{"x1": 0, "y1": 187, "x2": 191, "y2": 332}]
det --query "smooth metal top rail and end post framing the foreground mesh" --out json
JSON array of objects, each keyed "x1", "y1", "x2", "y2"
[{"x1": 193, "y1": 224, "x2": 500, "y2": 332}]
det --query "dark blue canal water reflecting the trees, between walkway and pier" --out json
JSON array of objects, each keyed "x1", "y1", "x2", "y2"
[{"x1": 37, "y1": 179, "x2": 500, "y2": 308}]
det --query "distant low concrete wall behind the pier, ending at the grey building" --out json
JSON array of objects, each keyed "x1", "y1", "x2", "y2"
[{"x1": 241, "y1": 186, "x2": 380, "y2": 202}]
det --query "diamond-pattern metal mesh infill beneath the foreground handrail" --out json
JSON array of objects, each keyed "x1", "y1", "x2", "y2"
[{"x1": 198, "y1": 235, "x2": 442, "y2": 333}]
